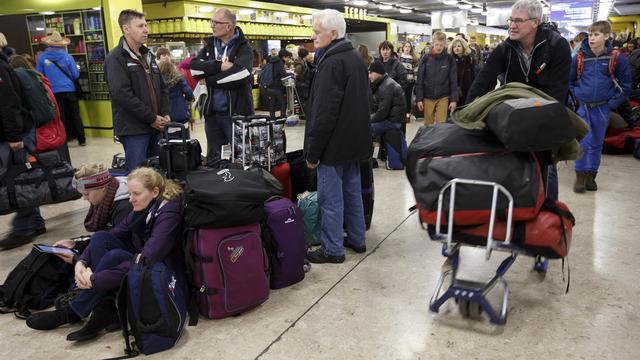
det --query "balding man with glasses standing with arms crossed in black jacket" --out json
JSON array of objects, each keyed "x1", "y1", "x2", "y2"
[{"x1": 189, "y1": 8, "x2": 253, "y2": 160}]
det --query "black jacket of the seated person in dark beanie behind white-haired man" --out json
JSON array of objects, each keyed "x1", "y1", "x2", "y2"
[{"x1": 371, "y1": 74, "x2": 407, "y2": 123}]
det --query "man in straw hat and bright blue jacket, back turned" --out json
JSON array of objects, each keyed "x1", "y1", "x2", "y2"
[{"x1": 36, "y1": 31, "x2": 86, "y2": 146}]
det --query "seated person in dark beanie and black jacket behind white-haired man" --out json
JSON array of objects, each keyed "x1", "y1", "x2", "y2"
[{"x1": 369, "y1": 61, "x2": 406, "y2": 136}]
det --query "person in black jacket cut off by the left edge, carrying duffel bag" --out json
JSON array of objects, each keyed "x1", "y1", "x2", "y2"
[{"x1": 0, "y1": 38, "x2": 46, "y2": 250}]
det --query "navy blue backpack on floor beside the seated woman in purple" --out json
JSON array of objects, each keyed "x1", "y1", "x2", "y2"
[{"x1": 118, "y1": 261, "x2": 189, "y2": 358}]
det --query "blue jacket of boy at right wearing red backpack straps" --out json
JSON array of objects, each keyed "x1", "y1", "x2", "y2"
[{"x1": 569, "y1": 39, "x2": 631, "y2": 110}]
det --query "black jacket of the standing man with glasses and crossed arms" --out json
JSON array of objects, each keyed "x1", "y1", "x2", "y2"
[{"x1": 189, "y1": 26, "x2": 254, "y2": 116}]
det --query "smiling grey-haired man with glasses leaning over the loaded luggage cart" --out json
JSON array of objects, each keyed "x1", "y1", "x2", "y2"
[{"x1": 467, "y1": 0, "x2": 571, "y2": 104}]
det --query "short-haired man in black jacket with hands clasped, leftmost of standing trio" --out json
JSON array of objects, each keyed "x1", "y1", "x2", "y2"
[{"x1": 104, "y1": 10, "x2": 171, "y2": 171}]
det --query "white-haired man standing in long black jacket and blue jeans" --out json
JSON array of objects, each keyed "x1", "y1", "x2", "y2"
[{"x1": 304, "y1": 9, "x2": 371, "y2": 263}]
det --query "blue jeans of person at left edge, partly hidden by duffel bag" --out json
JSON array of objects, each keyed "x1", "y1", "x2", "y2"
[{"x1": 0, "y1": 128, "x2": 44, "y2": 236}]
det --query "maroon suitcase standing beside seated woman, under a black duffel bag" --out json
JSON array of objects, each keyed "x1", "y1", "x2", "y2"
[{"x1": 191, "y1": 224, "x2": 269, "y2": 319}]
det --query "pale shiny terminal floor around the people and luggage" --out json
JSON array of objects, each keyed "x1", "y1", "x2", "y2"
[{"x1": 0, "y1": 123, "x2": 640, "y2": 360}]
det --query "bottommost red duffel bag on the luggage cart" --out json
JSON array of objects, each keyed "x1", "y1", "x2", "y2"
[{"x1": 429, "y1": 200, "x2": 575, "y2": 259}]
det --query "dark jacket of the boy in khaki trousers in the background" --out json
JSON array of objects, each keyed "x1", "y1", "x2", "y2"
[{"x1": 415, "y1": 51, "x2": 458, "y2": 102}]
